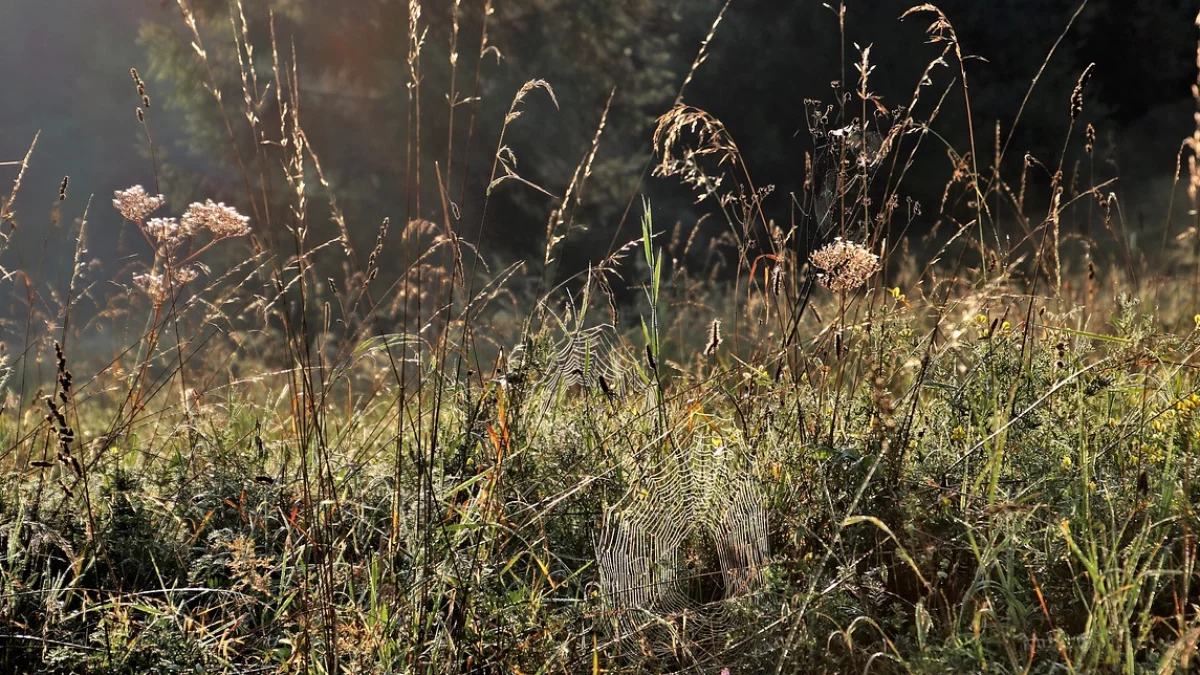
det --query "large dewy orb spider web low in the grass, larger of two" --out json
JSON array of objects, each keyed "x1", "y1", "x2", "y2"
[{"x1": 596, "y1": 443, "x2": 769, "y2": 663}]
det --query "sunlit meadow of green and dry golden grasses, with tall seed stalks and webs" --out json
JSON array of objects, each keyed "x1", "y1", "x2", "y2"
[{"x1": 0, "y1": 0, "x2": 1200, "y2": 675}]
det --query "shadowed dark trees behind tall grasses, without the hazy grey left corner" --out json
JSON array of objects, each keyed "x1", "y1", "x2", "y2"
[{"x1": 142, "y1": 0, "x2": 1198, "y2": 279}]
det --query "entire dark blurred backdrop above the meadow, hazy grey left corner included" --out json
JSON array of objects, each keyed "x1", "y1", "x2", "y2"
[{"x1": 0, "y1": 0, "x2": 1200, "y2": 288}]
